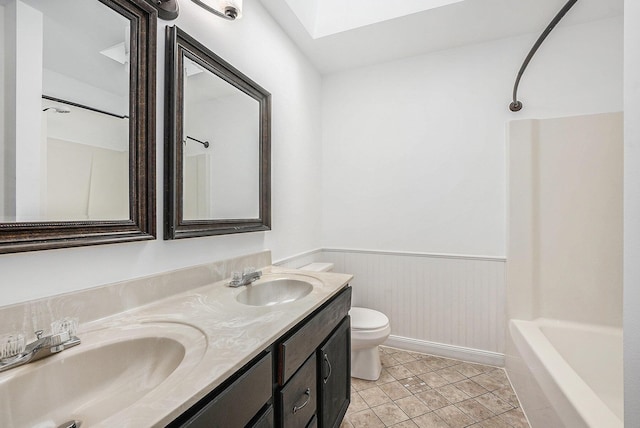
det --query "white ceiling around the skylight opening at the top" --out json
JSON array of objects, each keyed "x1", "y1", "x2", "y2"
[{"x1": 258, "y1": 0, "x2": 624, "y2": 73}]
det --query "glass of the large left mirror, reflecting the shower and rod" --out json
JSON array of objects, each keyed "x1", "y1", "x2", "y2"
[{"x1": 0, "y1": 0, "x2": 130, "y2": 222}]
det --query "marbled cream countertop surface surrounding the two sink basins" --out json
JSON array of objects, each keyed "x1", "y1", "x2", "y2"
[{"x1": 68, "y1": 266, "x2": 352, "y2": 427}]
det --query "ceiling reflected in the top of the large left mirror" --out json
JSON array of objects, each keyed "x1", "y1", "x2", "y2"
[{"x1": 16, "y1": 0, "x2": 129, "y2": 110}]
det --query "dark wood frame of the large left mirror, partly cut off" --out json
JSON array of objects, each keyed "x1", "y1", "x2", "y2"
[{"x1": 0, "y1": 0, "x2": 158, "y2": 254}]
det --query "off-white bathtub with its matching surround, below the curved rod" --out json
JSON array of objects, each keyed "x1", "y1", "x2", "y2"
[{"x1": 506, "y1": 113, "x2": 623, "y2": 428}]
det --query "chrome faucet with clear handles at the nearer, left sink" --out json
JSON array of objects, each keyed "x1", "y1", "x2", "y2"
[{"x1": 0, "y1": 320, "x2": 80, "y2": 372}]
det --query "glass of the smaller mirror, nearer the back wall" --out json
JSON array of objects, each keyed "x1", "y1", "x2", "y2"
[{"x1": 183, "y1": 58, "x2": 260, "y2": 220}]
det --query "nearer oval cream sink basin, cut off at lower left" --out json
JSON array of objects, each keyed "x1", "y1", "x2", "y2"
[{"x1": 0, "y1": 322, "x2": 207, "y2": 428}]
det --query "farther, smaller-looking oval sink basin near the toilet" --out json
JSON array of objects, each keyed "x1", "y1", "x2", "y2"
[{"x1": 236, "y1": 278, "x2": 313, "y2": 306}]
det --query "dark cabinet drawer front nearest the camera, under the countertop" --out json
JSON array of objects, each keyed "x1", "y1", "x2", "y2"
[{"x1": 182, "y1": 352, "x2": 273, "y2": 428}]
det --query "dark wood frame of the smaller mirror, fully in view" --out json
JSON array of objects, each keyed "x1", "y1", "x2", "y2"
[{"x1": 164, "y1": 26, "x2": 271, "y2": 239}]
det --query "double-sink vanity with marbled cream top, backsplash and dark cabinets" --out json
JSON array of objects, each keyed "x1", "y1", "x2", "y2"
[{"x1": 0, "y1": 251, "x2": 351, "y2": 428}]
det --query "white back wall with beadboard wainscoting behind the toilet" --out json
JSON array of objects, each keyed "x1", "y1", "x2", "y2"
[{"x1": 322, "y1": 17, "x2": 623, "y2": 363}]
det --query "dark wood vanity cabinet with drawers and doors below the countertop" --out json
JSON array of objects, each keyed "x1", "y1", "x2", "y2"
[{"x1": 169, "y1": 286, "x2": 351, "y2": 428}]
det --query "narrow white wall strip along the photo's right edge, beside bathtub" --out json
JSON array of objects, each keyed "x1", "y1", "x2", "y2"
[{"x1": 623, "y1": 0, "x2": 640, "y2": 427}]
